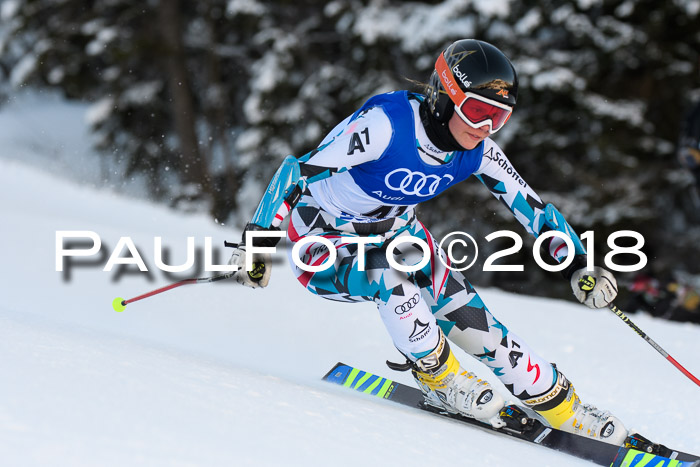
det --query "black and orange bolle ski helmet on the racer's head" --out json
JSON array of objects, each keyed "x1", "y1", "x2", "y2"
[{"x1": 426, "y1": 39, "x2": 518, "y2": 122}]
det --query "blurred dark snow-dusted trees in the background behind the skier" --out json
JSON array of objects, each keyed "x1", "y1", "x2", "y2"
[{"x1": 0, "y1": 0, "x2": 700, "y2": 291}]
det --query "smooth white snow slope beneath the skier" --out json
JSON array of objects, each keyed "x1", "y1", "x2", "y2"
[{"x1": 0, "y1": 96, "x2": 700, "y2": 467}]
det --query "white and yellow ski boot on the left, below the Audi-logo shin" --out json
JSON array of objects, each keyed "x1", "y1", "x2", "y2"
[{"x1": 412, "y1": 330, "x2": 505, "y2": 428}]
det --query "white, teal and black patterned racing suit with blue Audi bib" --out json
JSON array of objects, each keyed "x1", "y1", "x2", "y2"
[{"x1": 266, "y1": 91, "x2": 567, "y2": 399}]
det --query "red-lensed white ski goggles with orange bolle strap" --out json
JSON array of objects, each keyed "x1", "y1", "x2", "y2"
[{"x1": 435, "y1": 54, "x2": 513, "y2": 134}]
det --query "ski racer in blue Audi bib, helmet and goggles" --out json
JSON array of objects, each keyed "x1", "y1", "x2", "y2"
[{"x1": 229, "y1": 39, "x2": 628, "y2": 445}]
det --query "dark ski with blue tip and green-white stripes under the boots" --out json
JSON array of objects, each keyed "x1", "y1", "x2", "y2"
[{"x1": 323, "y1": 362, "x2": 700, "y2": 467}]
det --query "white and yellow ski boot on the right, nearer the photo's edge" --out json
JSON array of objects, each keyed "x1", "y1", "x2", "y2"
[{"x1": 523, "y1": 370, "x2": 628, "y2": 446}]
